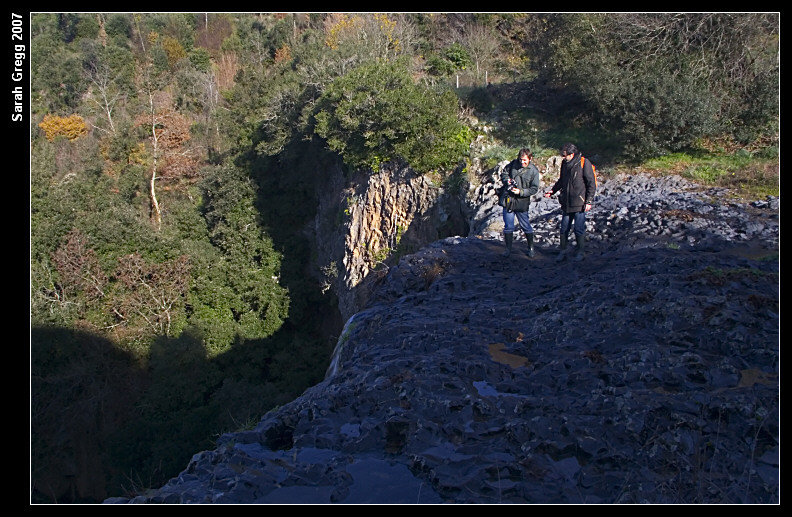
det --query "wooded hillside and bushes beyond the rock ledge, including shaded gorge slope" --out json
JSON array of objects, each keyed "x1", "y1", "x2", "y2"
[{"x1": 30, "y1": 13, "x2": 780, "y2": 502}]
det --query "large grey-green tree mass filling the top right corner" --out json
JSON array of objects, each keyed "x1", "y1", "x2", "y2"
[{"x1": 529, "y1": 13, "x2": 780, "y2": 158}]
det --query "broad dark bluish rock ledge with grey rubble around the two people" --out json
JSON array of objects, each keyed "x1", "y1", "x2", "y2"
[{"x1": 107, "y1": 171, "x2": 780, "y2": 504}]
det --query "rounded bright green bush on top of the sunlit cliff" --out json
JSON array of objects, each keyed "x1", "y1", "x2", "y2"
[{"x1": 315, "y1": 58, "x2": 470, "y2": 172}]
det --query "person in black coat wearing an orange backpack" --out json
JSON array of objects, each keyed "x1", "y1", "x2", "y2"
[{"x1": 544, "y1": 144, "x2": 597, "y2": 262}]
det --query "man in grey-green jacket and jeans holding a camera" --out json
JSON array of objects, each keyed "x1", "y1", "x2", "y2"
[{"x1": 499, "y1": 148, "x2": 541, "y2": 258}]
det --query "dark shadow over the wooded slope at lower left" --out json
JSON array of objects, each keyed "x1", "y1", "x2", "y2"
[{"x1": 30, "y1": 296, "x2": 334, "y2": 504}]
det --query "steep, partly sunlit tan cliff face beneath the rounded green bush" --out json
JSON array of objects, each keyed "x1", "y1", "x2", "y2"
[{"x1": 313, "y1": 164, "x2": 467, "y2": 320}]
